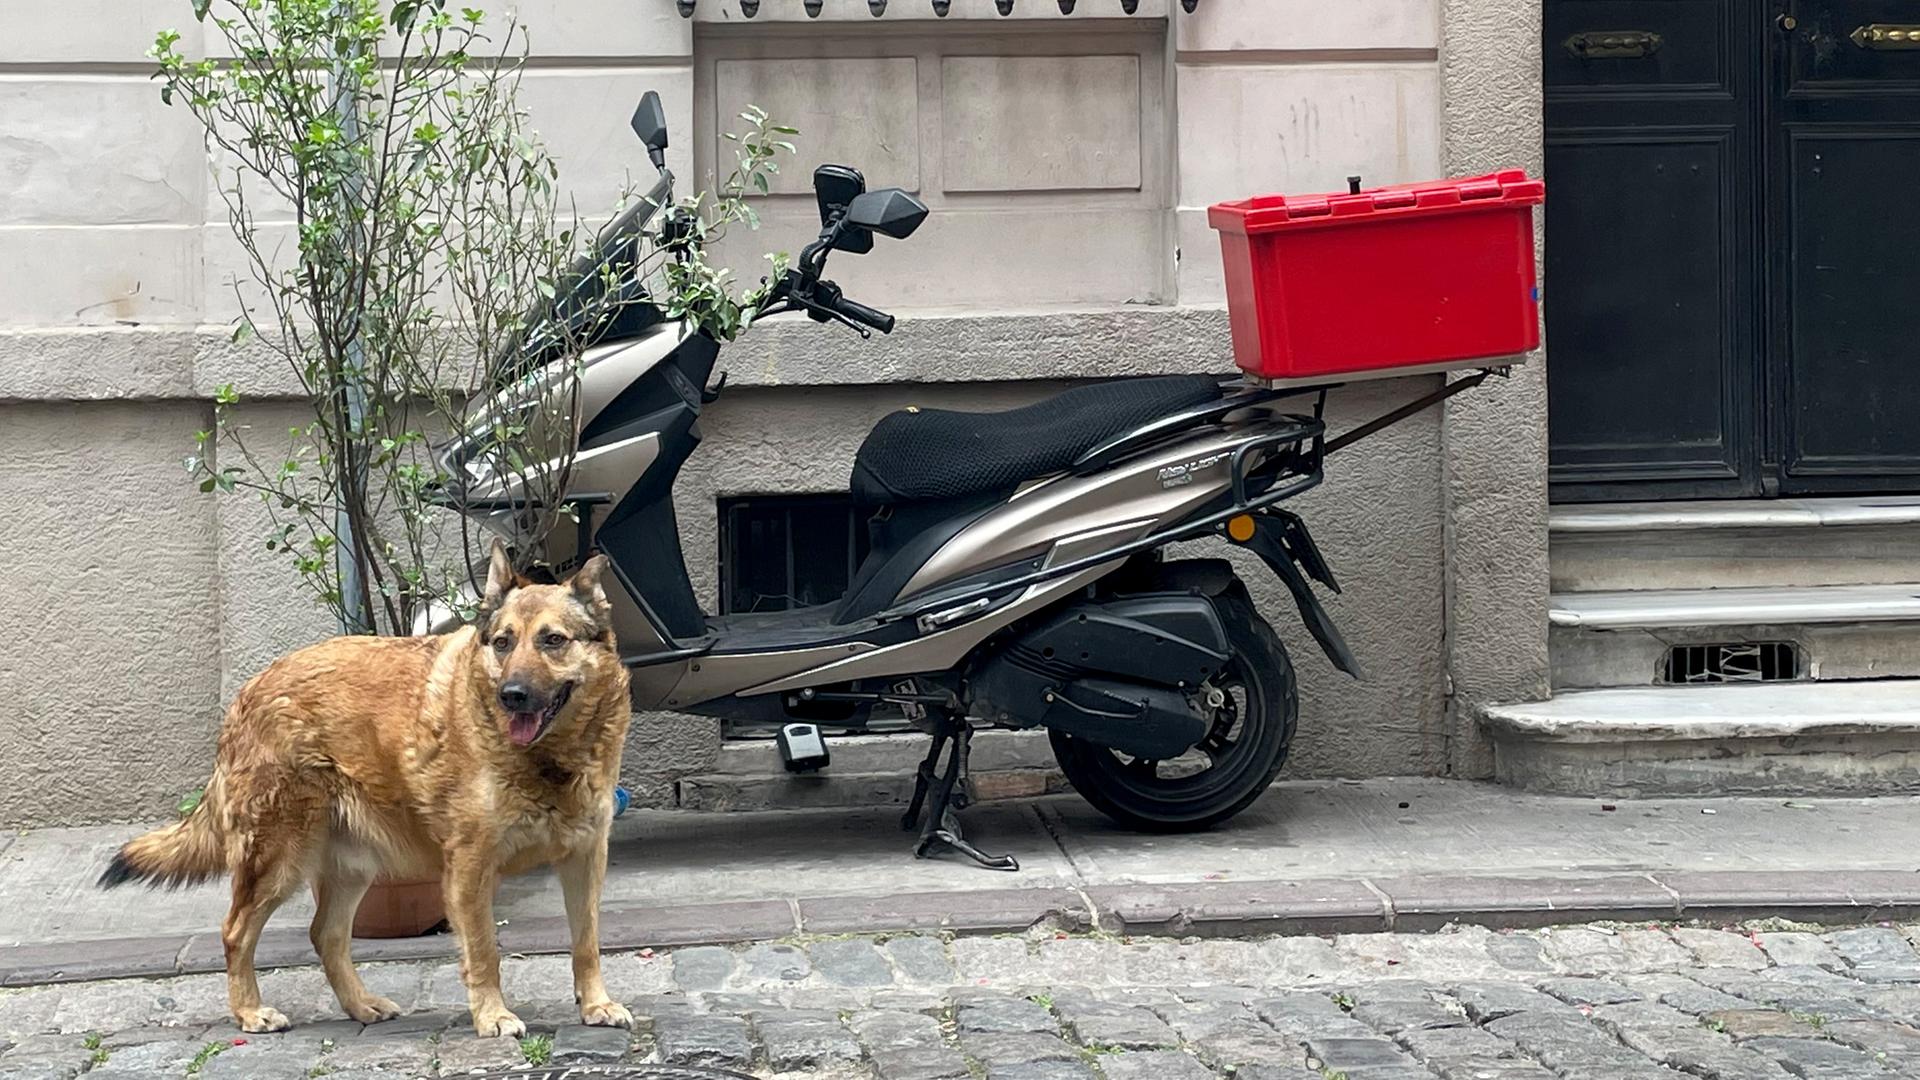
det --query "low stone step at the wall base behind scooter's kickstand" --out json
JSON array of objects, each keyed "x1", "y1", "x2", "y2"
[{"x1": 678, "y1": 730, "x2": 1069, "y2": 811}]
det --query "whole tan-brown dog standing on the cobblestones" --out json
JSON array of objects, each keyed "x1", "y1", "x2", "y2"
[{"x1": 100, "y1": 544, "x2": 634, "y2": 1038}]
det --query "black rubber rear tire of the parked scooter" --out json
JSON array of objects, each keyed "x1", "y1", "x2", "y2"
[{"x1": 1046, "y1": 588, "x2": 1300, "y2": 832}]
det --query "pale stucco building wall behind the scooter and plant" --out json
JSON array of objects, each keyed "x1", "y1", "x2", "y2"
[{"x1": 0, "y1": 0, "x2": 1546, "y2": 824}]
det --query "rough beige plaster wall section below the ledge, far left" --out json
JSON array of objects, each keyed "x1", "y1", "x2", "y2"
[{"x1": 0, "y1": 402, "x2": 221, "y2": 824}]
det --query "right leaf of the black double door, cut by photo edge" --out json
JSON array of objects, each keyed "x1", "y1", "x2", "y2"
[{"x1": 1768, "y1": 0, "x2": 1920, "y2": 492}]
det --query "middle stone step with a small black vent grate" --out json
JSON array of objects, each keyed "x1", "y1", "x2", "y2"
[{"x1": 1548, "y1": 584, "x2": 1920, "y2": 690}]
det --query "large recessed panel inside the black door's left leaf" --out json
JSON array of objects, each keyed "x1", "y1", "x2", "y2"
[{"x1": 1548, "y1": 129, "x2": 1745, "y2": 480}]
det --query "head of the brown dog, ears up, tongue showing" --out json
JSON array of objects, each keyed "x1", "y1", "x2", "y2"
[{"x1": 478, "y1": 542, "x2": 618, "y2": 746}]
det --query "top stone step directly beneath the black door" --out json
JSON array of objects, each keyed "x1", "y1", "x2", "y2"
[{"x1": 1548, "y1": 496, "x2": 1920, "y2": 592}]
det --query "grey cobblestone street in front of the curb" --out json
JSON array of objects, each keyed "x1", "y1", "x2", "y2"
[{"x1": 0, "y1": 924, "x2": 1920, "y2": 1080}]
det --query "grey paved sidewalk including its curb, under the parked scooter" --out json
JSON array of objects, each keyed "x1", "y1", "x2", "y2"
[{"x1": 0, "y1": 780, "x2": 1920, "y2": 986}]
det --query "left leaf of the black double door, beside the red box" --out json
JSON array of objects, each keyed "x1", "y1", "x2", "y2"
[{"x1": 1544, "y1": 0, "x2": 1763, "y2": 502}]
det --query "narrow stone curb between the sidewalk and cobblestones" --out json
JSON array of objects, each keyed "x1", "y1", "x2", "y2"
[{"x1": 0, "y1": 871, "x2": 1920, "y2": 988}]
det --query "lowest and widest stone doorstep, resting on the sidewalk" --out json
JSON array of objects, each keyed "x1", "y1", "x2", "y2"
[{"x1": 1484, "y1": 678, "x2": 1920, "y2": 798}]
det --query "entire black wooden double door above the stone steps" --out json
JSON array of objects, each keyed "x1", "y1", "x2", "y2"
[{"x1": 1546, "y1": 0, "x2": 1920, "y2": 502}]
